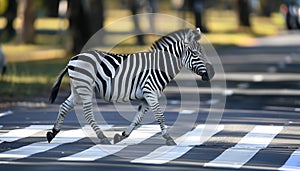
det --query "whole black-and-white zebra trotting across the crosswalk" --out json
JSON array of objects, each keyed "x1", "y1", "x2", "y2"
[{"x1": 46, "y1": 28, "x2": 214, "y2": 145}]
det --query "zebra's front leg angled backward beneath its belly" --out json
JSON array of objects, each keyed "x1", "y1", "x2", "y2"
[{"x1": 114, "y1": 100, "x2": 148, "y2": 144}]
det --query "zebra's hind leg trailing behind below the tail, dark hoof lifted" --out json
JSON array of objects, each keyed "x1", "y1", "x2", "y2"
[{"x1": 46, "y1": 94, "x2": 75, "y2": 143}]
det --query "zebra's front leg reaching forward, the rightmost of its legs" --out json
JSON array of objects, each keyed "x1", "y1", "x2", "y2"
[{"x1": 144, "y1": 91, "x2": 176, "y2": 146}]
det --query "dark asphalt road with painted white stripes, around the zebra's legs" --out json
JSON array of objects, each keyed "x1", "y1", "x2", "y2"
[{"x1": 0, "y1": 33, "x2": 300, "y2": 171}]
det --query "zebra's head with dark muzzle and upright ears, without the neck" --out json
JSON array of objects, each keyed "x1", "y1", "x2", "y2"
[{"x1": 182, "y1": 28, "x2": 215, "y2": 81}]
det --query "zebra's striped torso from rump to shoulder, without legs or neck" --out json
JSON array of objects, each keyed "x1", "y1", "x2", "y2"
[{"x1": 68, "y1": 51, "x2": 181, "y2": 102}]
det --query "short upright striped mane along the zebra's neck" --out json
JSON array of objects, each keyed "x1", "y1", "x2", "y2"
[{"x1": 150, "y1": 29, "x2": 190, "y2": 51}]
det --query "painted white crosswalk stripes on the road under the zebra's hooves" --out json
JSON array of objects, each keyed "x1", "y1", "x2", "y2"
[{"x1": 0, "y1": 124, "x2": 300, "y2": 170}]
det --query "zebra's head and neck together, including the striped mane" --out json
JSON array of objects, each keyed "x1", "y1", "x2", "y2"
[{"x1": 150, "y1": 28, "x2": 215, "y2": 81}]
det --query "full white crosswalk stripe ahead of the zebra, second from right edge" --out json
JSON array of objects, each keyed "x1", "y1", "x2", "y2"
[{"x1": 204, "y1": 126, "x2": 283, "y2": 168}]
